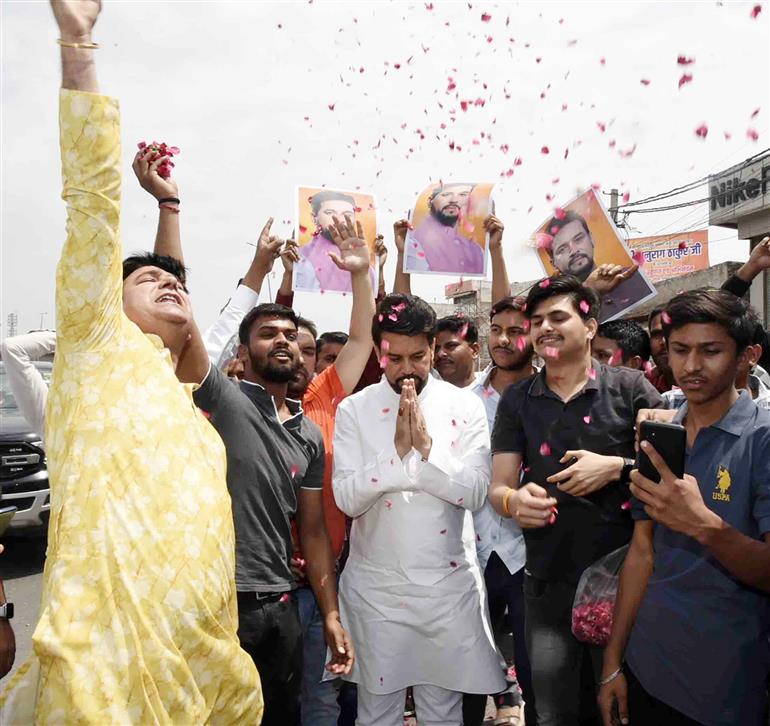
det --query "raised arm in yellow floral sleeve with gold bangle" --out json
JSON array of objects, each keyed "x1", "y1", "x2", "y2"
[{"x1": 52, "y1": 0, "x2": 123, "y2": 353}]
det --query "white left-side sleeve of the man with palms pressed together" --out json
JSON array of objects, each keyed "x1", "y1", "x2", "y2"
[{"x1": 332, "y1": 400, "x2": 414, "y2": 517}]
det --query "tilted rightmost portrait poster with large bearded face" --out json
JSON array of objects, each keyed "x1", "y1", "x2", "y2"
[{"x1": 534, "y1": 189, "x2": 657, "y2": 323}]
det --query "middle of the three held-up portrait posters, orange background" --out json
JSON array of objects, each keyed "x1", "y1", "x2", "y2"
[{"x1": 404, "y1": 182, "x2": 495, "y2": 277}]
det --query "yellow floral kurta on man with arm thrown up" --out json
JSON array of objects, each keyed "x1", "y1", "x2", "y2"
[{"x1": 0, "y1": 90, "x2": 262, "y2": 724}]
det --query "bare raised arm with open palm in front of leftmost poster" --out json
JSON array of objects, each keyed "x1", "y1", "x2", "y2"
[{"x1": 324, "y1": 217, "x2": 374, "y2": 395}]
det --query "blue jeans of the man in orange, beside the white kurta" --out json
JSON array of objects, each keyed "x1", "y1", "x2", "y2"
[{"x1": 294, "y1": 587, "x2": 340, "y2": 726}]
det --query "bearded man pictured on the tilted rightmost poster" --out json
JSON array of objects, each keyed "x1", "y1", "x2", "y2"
[{"x1": 545, "y1": 211, "x2": 650, "y2": 323}]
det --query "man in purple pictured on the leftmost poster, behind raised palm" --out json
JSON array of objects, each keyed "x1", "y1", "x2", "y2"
[{"x1": 294, "y1": 190, "x2": 377, "y2": 292}]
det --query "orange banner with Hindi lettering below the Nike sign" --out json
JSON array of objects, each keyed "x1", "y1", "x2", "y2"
[{"x1": 628, "y1": 229, "x2": 709, "y2": 282}]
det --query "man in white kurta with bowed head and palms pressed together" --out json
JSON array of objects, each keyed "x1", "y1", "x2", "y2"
[{"x1": 333, "y1": 295, "x2": 505, "y2": 726}]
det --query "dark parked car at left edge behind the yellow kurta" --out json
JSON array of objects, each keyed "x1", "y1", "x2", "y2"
[{"x1": 0, "y1": 362, "x2": 52, "y2": 534}]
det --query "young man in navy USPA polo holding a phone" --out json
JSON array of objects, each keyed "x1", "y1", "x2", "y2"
[{"x1": 599, "y1": 290, "x2": 770, "y2": 726}]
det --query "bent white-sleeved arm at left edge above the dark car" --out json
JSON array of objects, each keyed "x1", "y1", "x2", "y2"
[{"x1": 0, "y1": 330, "x2": 56, "y2": 435}]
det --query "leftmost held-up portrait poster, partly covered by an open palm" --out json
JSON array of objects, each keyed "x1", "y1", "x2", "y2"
[{"x1": 293, "y1": 186, "x2": 378, "y2": 294}]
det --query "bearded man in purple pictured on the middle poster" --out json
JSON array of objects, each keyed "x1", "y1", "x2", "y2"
[{"x1": 406, "y1": 184, "x2": 484, "y2": 275}]
